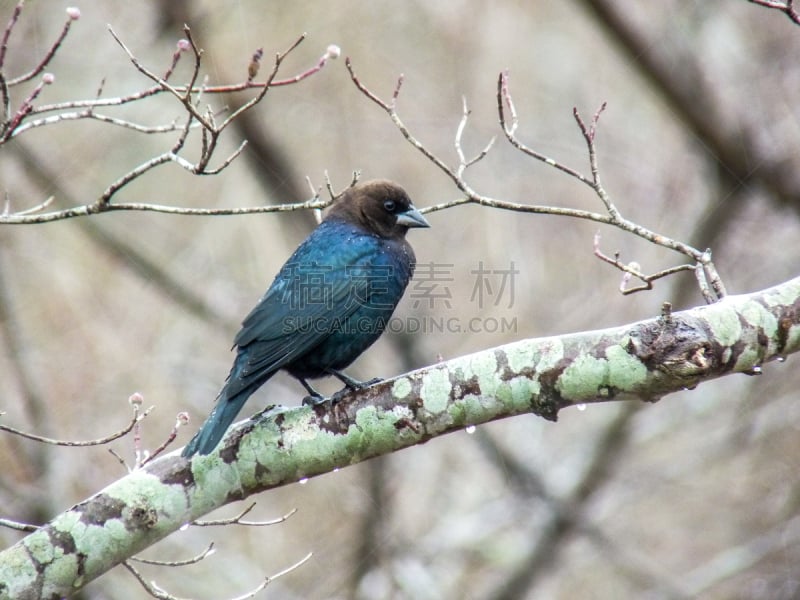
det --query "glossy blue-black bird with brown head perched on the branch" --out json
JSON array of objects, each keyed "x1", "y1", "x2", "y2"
[{"x1": 182, "y1": 179, "x2": 430, "y2": 458}]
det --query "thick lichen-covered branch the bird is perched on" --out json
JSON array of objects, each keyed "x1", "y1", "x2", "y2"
[{"x1": 0, "y1": 277, "x2": 800, "y2": 598}]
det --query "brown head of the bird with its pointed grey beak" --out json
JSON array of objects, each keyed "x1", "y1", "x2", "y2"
[{"x1": 326, "y1": 179, "x2": 430, "y2": 238}]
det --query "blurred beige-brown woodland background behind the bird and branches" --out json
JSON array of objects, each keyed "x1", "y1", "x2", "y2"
[{"x1": 0, "y1": 0, "x2": 800, "y2": 599}]
